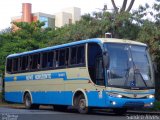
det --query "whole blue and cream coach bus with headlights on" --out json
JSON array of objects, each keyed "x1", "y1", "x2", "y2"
[{"x1": 5, "y1": 38, "x2": 155, "y2": 114}]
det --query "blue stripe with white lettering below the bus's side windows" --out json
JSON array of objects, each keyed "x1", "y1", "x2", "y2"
[{"x1": 5, "y1": 72, "x2": 89, "y2": 82}]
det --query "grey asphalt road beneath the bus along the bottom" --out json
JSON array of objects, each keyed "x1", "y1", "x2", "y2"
[{"x1": 0, "y1": 107, "x2": 160, "y2": 120}]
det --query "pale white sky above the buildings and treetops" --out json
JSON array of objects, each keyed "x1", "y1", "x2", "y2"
[{"x1": 0, "y1": 0, "x2": 154, "y2": 30}]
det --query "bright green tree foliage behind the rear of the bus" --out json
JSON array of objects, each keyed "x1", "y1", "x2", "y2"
[{"x1": 0, "y1": 21, "x2": 55, "y2": 73}]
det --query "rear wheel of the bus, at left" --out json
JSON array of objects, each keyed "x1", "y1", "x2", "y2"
[{"x1": 24, "y1": 93, "x2": 32, "y2": 109}]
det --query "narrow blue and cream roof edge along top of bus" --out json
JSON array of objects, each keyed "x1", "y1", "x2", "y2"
[{"x1": 7, "y1": 38, "x2": 147, "y2": 58}]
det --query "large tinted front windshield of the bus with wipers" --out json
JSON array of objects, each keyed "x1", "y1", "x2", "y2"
[{"x1": 105, "y1": 43, "x2": 154, "y2": 89}]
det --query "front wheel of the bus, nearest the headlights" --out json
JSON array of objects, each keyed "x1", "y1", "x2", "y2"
[{"x1": 77, "y1": 94, "x2": 89, "y2": 114}]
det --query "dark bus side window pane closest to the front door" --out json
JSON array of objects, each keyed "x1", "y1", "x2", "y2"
[{"x1": 77, "y1": 46, "x2": 85, "y2": 64}]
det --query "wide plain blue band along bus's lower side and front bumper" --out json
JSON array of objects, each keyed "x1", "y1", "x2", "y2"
[{"x1": 5, "y1": 91, "x2": 155, "y2": 108}]
